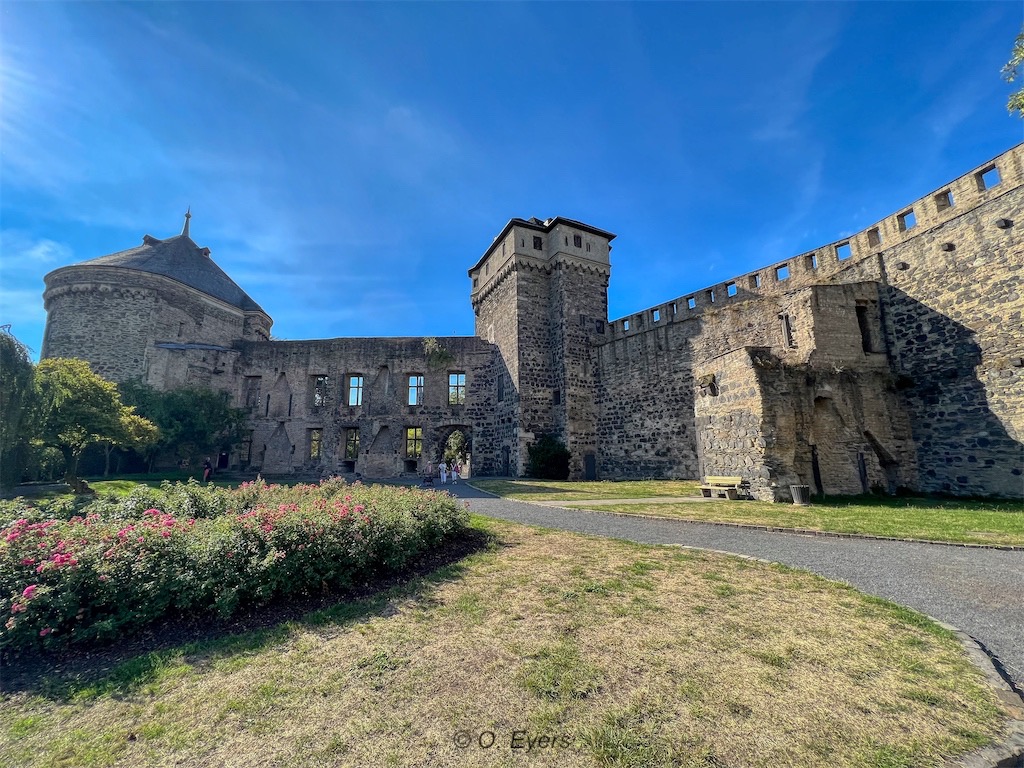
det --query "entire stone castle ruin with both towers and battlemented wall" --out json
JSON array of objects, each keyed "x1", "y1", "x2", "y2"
[{"x1": 43, "y1": 145, "x2": 1024, "y2": 501}]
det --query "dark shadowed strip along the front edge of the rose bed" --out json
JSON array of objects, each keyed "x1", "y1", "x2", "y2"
[{"x1": 0, "y1": 524, "x2": 507, "y2": 702}]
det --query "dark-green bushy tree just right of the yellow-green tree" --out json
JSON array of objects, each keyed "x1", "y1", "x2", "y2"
[{"x1": 121, "y1": 382, "x2": 246, "y2": 462}]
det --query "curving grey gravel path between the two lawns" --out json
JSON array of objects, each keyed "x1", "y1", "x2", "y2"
[{"x1": 448, "y1": 483, "x2": 1024, "y2": 689}]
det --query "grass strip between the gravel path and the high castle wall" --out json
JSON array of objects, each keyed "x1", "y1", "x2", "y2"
[{"x1": 474, "y1": 480, "x2": 1024, "y2": 546}]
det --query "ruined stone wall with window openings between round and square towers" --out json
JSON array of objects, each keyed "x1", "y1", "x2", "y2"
[{"x1": 233, "y1": 337, "x2": 507, "y2": 477}]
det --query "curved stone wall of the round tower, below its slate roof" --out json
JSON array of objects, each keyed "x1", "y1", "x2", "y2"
[{"x1": 42, "y1": 266, "x2": 244, "y2": 389}]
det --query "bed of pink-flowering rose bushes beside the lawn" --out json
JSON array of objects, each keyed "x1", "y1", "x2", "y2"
[{"x1": 0, "y1": 480, "x2": 468, "y2": 652}]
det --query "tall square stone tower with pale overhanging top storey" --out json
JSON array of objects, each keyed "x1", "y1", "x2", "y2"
[{"x1": 469, "y1": 217, "x2": 615, "y2": 478}]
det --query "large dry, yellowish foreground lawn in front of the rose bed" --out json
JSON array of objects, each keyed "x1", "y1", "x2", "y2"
[{"x1": 0, "y1": 518, "x2": 1002, "y2": 768}]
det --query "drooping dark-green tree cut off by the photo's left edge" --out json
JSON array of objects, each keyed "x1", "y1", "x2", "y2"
[{"x1": 0, "y1": 326, "x2": 35, "y2": 488}]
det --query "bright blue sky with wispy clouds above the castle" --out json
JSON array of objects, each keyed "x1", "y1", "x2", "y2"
[{"x1": 0, "y1": 2, "x2": 1024, "y2": 355}]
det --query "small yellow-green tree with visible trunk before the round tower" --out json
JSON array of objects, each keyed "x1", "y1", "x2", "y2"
[{"x1": 34, "y1": 357, "x2": 158, "y2": 490}]
